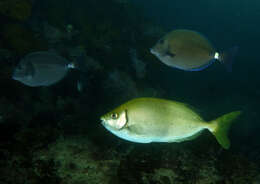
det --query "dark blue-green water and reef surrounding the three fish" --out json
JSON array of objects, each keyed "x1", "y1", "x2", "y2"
[{"x1": 0, "y1": 0, "x2": 260, "y2": 184}]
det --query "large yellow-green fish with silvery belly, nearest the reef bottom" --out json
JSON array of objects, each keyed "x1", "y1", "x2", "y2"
[{"x1": 101, "y1": 98, "x2": 240, "y2": 149}]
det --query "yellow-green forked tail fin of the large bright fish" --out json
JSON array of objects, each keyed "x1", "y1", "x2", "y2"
[{"x1": 209, "y1": 111, "x2": 241, "y2": 149}]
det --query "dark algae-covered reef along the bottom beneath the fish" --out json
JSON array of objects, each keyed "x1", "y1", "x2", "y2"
[{"x1": 0, "y1": 126, "x2": 259, "y2": 184}]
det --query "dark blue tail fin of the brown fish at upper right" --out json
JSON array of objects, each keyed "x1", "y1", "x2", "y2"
[{"x1": 220, "y1": 46, "x2": 238, "y2": 72}]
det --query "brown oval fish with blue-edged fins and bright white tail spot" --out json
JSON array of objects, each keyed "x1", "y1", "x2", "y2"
[{"x1": 150, "y1": 29, "x2": 238, "y2": 71}]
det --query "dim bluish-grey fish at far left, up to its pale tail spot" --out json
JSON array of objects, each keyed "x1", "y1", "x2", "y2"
[{"x1": 12, "y1": 51, "x2": 79, "y2": 87}]
